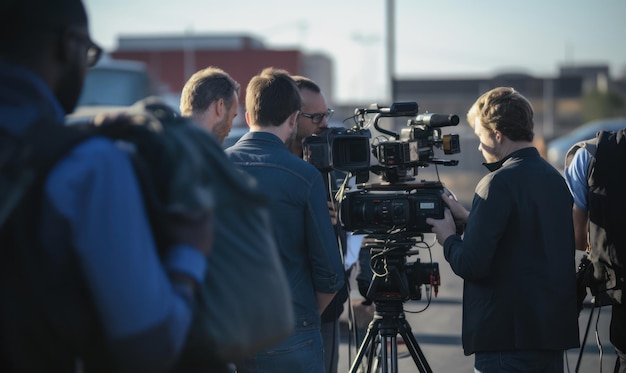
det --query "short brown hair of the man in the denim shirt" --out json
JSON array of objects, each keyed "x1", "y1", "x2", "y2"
[{"x1": 246, "y1": 67, "x2": 302, "y2": 127}]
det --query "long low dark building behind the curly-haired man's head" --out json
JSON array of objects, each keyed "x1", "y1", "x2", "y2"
[{"x1": 392, "y1": 65, "x2": 626, "y2": 138}]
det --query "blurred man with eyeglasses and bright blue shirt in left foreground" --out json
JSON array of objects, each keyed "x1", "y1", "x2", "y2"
[{"x1": 0, "y1": 0, "x2": 212, "y2": 372}]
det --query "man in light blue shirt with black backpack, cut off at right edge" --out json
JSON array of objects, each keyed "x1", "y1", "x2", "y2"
[{"x1": 565, "y1": 129, "x2": 626, "y2": 373}]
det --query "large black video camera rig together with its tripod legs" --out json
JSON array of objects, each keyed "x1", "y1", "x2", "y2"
[{"x1": 302, "y1": 102, "x2": 460, "y2": 366}]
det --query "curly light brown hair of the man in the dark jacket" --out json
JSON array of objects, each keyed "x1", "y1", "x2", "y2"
[{"x1": 467, "y1": 87, "x2": 534, "y2": 141}]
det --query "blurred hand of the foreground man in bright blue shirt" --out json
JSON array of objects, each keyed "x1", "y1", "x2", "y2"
[{"x1": 168, "y1": 211, "x2": 213, "y2": 255}]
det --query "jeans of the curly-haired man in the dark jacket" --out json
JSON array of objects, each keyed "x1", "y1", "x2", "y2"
[{"x1": 474, "y1": 351, "x2": 564, "y2": 373}]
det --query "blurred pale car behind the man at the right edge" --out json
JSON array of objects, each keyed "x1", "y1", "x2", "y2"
[{"x1": 546, "y1": 118, "x2": 626, "y2": 170}]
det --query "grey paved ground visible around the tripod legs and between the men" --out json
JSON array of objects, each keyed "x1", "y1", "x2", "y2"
[{"x1": 339, "y1": 158, "x2": 615, "y2": 373}]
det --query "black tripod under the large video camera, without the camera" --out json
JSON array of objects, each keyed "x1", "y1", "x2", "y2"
[{"x1": 350, "y1": 240, "x2": 439, "y2": 373}]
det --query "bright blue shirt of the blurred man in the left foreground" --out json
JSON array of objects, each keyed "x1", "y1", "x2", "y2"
[{"x1": 0, "y1": 61, "x2": 206, "y2": 371}]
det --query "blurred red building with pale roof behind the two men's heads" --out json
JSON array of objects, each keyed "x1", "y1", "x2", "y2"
[{"x1": 111, "y1": 34, "x2": 333, "y2": 125}]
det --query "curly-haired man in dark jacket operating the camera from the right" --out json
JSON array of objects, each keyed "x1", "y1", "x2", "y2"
[{"x1": 427, "y1": 87, "x2": 579, "y2": 372}]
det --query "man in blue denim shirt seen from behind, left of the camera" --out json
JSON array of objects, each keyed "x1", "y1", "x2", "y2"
[{"x1": 226, "y1": 68, "x2": 344, "y2": 373}]
